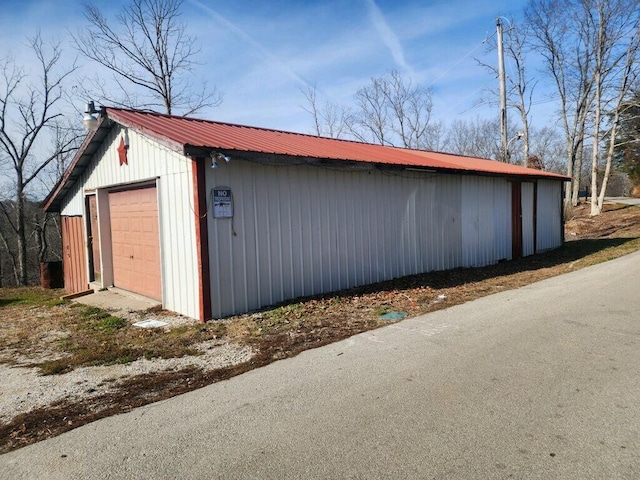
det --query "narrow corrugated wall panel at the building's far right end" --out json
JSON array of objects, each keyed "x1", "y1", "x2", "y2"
[{"x1": 536, "y1": 180, "x2": 563, "y2": 252}]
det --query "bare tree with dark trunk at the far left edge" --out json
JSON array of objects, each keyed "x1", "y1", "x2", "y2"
[{"x1": 0, "y1": 34, "x2": 78, "y2": 285}]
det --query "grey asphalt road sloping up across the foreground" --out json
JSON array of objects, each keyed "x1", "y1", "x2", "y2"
[{"x1": 0, "y1": 249, "x2": 640, "y2": 480}]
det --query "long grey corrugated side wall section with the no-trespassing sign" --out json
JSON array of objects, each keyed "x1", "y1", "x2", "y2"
[{"x1": 207, "y1": 159, "x2": 470, "y2": 317}]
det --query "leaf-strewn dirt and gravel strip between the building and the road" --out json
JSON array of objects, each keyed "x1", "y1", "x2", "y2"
[{"x1": 0, "y1": 205, "x2": 640, "y2": 452}]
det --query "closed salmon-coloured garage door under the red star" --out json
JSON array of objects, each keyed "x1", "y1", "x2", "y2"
[{"x1": 109, "y1": 186, "x2": 162, "y2": 300}]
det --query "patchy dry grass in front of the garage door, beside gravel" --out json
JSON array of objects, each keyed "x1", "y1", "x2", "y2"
[{"x1": 0, "y1": 298, "x2": 230, "y2": 375}]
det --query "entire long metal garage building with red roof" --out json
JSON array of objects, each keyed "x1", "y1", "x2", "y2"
[{"x1": 45, "y1": 108, "x2": 566, "y2": 321}]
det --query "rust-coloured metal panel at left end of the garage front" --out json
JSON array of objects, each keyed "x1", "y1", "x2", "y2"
[{"x1": 62, "y1": 217, "x2": 89, "y2": 293}]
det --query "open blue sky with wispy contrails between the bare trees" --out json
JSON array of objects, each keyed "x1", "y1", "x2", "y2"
[{"x1": 0, "y1": 0, "x2": 546, "y2": 132}]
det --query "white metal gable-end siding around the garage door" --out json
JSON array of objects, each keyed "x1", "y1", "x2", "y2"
[{"x1": 62, "y1": 127, "x2": 200, "y2": 318}]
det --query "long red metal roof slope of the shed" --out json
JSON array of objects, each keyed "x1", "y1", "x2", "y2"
[{"x1": 106, "y1": 108, "x2": 566, "y2": 180}]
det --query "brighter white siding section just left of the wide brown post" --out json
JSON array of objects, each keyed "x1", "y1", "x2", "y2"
[{"x1": 462, "y1": 176, "x2": 511, "y2": 267}]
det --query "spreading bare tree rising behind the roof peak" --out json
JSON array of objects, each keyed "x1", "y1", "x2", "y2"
[{"x1": 73, "y1": 0, "x2": 222, "y2": 116}]
